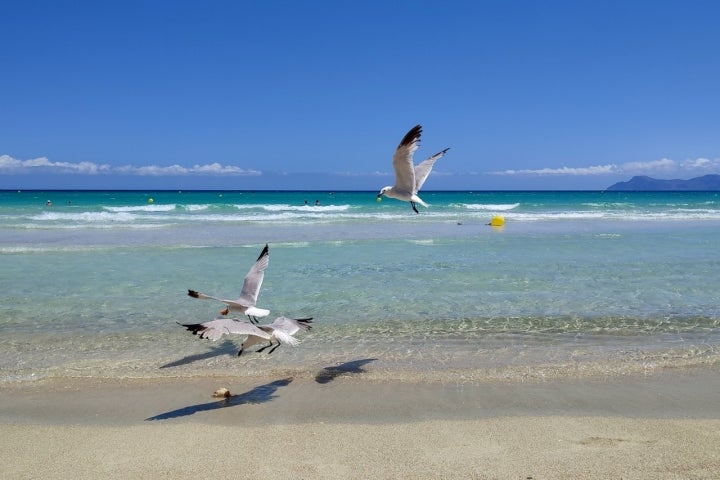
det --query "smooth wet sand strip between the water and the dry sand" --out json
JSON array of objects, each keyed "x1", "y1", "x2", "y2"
[{"x1": 0, "y1": 365, "x2": 720, "y2": 426}]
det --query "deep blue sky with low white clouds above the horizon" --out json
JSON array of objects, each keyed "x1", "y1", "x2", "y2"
[{"x1": 0, "y1": 0, "x2": 720, "y2": 190}]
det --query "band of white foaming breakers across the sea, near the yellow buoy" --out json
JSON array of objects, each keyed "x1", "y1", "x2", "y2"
[{"x1": 9, "y1": 203, "x2": 720, "y2": 229}]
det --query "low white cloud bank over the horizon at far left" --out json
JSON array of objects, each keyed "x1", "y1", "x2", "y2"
[{"x1": 0, "y1": 155, "x2": 262, "y2": 176}]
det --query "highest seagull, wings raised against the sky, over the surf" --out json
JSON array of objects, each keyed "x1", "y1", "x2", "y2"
[{"x1": 378, "y1": 125, "x2": 450, "y2": 213}]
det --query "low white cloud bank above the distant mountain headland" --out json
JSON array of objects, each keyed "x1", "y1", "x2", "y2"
[{"x1": 488, "y1": 158, "x2": 720, "y2": 176}]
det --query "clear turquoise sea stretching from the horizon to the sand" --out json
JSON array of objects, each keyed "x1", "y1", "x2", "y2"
[{"x1": 0, "y1": 191, "x2": 720, "y2": 383}]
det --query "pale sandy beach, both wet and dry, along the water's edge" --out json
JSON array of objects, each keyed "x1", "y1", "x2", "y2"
[{"x1": 0, "y1": 369, "x2": 720, "y2": 479}]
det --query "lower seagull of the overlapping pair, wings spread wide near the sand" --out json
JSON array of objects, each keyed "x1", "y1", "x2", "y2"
[{"x1": 178, "y1": 317, "x2": 312, "y2": 356}]
